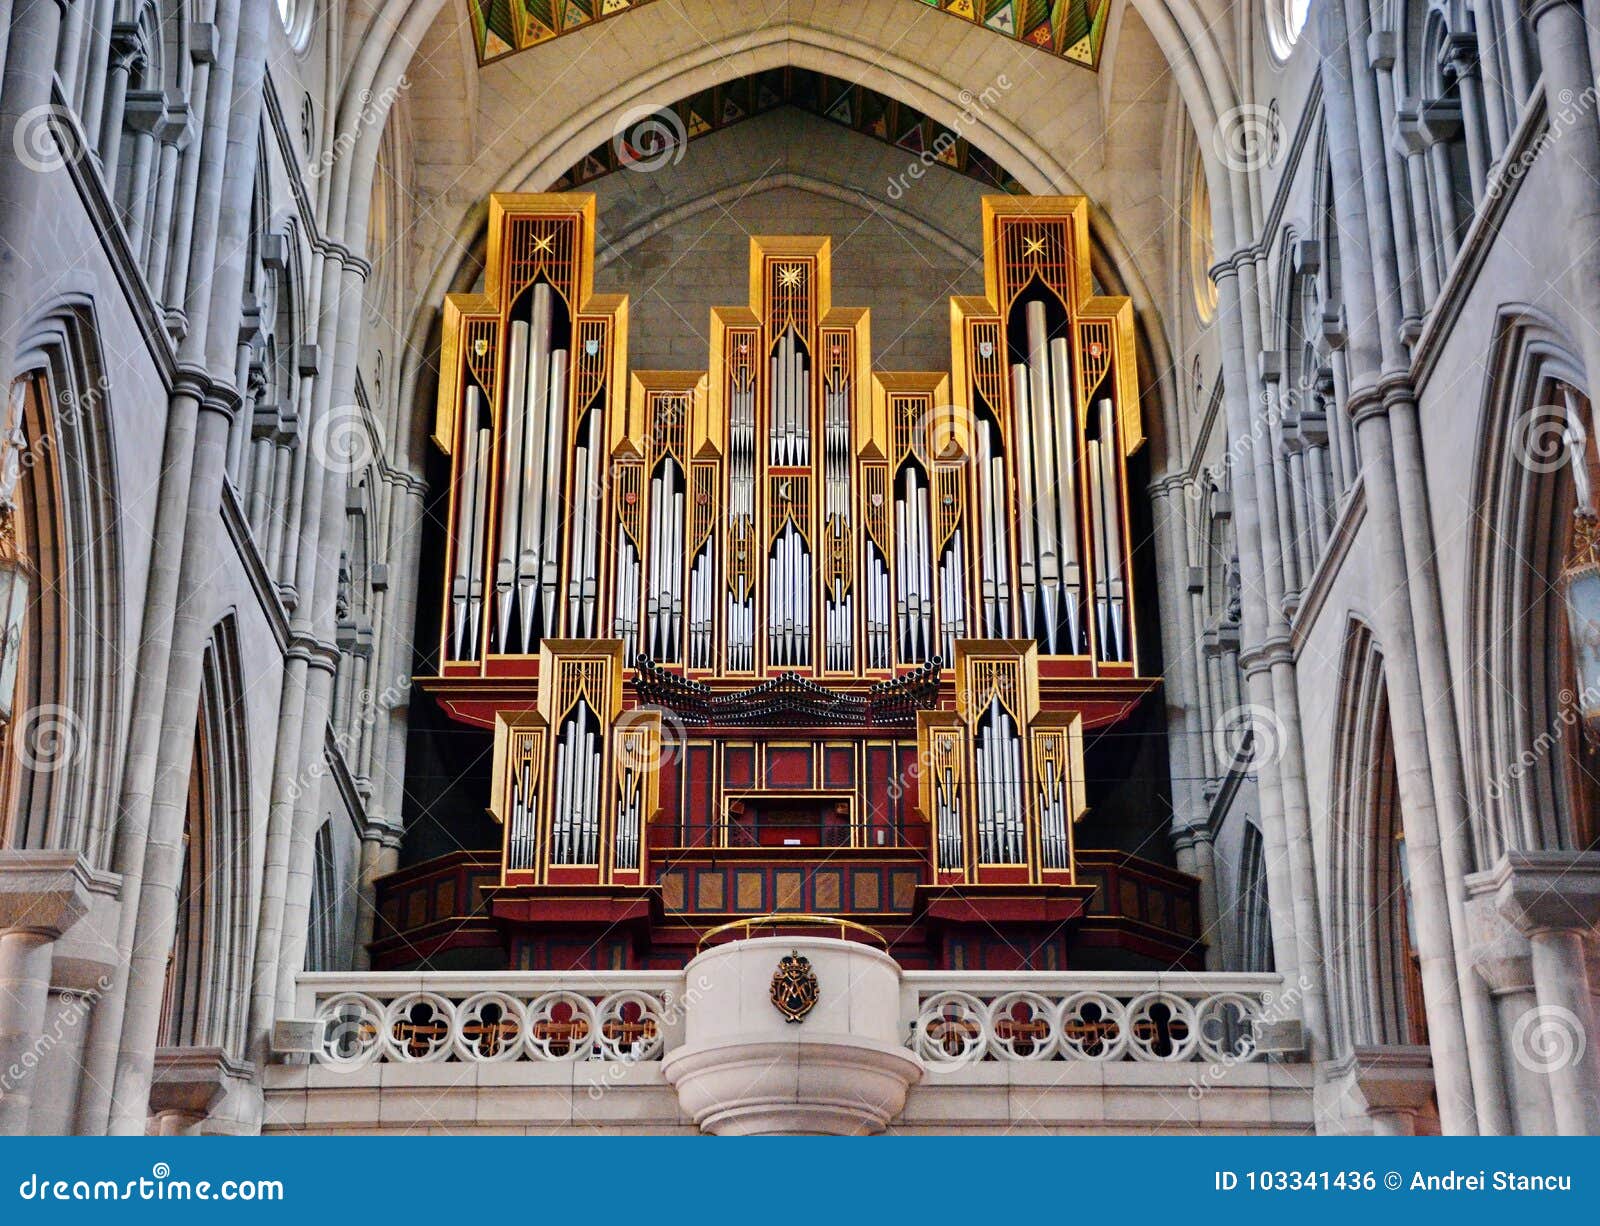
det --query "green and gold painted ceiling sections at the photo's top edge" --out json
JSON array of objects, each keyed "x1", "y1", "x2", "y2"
[{"x1": 466, "y1": 0, "x2": 1110, "y2": 69}]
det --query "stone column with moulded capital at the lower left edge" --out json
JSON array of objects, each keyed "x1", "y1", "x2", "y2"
[{"x1": 0, "y1": 850, "x2": 94, "y2": 1136}]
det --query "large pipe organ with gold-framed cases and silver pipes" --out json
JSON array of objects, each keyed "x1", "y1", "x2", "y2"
[{"x1": 421, "y1": 195, "x2": 1157, "y2": 967}]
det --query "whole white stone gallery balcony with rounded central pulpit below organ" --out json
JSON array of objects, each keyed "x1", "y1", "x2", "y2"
[{"x1": 266, "y1": 960, "x2": 1312, "y2": 1133}]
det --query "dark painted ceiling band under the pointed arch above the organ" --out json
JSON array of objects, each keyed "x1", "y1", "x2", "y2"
[{"x1": 550, "y1": 69, "x2": 1022, "y2": 192}]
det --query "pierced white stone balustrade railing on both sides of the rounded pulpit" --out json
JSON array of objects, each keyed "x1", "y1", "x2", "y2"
[{"x1": 301, "y1": 972, "x2": 1294, "y2": 1074}]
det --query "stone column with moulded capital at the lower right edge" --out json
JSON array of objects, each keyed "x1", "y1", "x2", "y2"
[{"x1": 1488, "y1": 851, "x2": 1600, "y2": 1136}]
